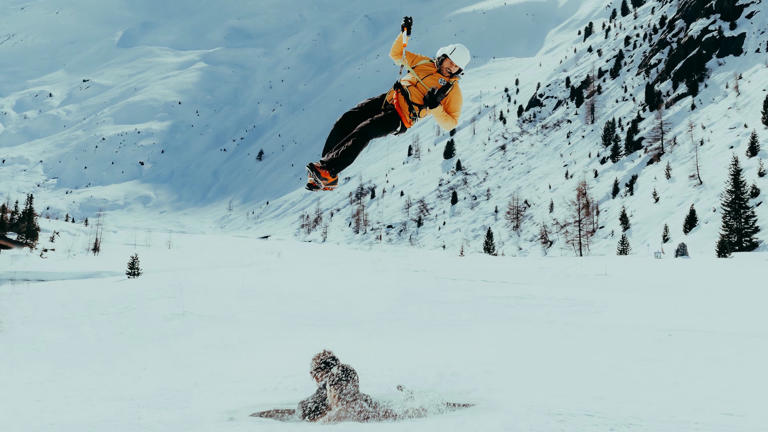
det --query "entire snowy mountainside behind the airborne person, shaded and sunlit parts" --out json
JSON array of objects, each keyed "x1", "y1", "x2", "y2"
[{"x1": 0, "y1": 0, "x2": 768, "y2": 255}]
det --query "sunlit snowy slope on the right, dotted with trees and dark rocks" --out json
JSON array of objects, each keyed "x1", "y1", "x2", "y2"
[{"x1": 237, "y1": 2, "x2": 768, "y2": 256}]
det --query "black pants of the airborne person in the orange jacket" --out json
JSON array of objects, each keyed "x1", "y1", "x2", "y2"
[{"x1": 320, "y1": 93, "x2": 401, "y2": 175}]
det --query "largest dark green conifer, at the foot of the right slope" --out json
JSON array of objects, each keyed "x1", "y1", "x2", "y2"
[{"x1": 717, "y1": 156, "x2": 760, "y2": 256}]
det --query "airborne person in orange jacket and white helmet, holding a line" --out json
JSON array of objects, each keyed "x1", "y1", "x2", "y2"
[{"x1": 307, "y1": 17, "x2": 471, "y2": 191}]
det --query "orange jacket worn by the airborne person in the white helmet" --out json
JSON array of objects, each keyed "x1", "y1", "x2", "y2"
[{"x1": 387, "y1": 33, "x2": 463, "y2": 130}]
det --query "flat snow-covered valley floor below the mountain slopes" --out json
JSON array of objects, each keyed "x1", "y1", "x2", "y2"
[{"x1": 0, "y1": 232, "x2": 768, "y2": 432}]
